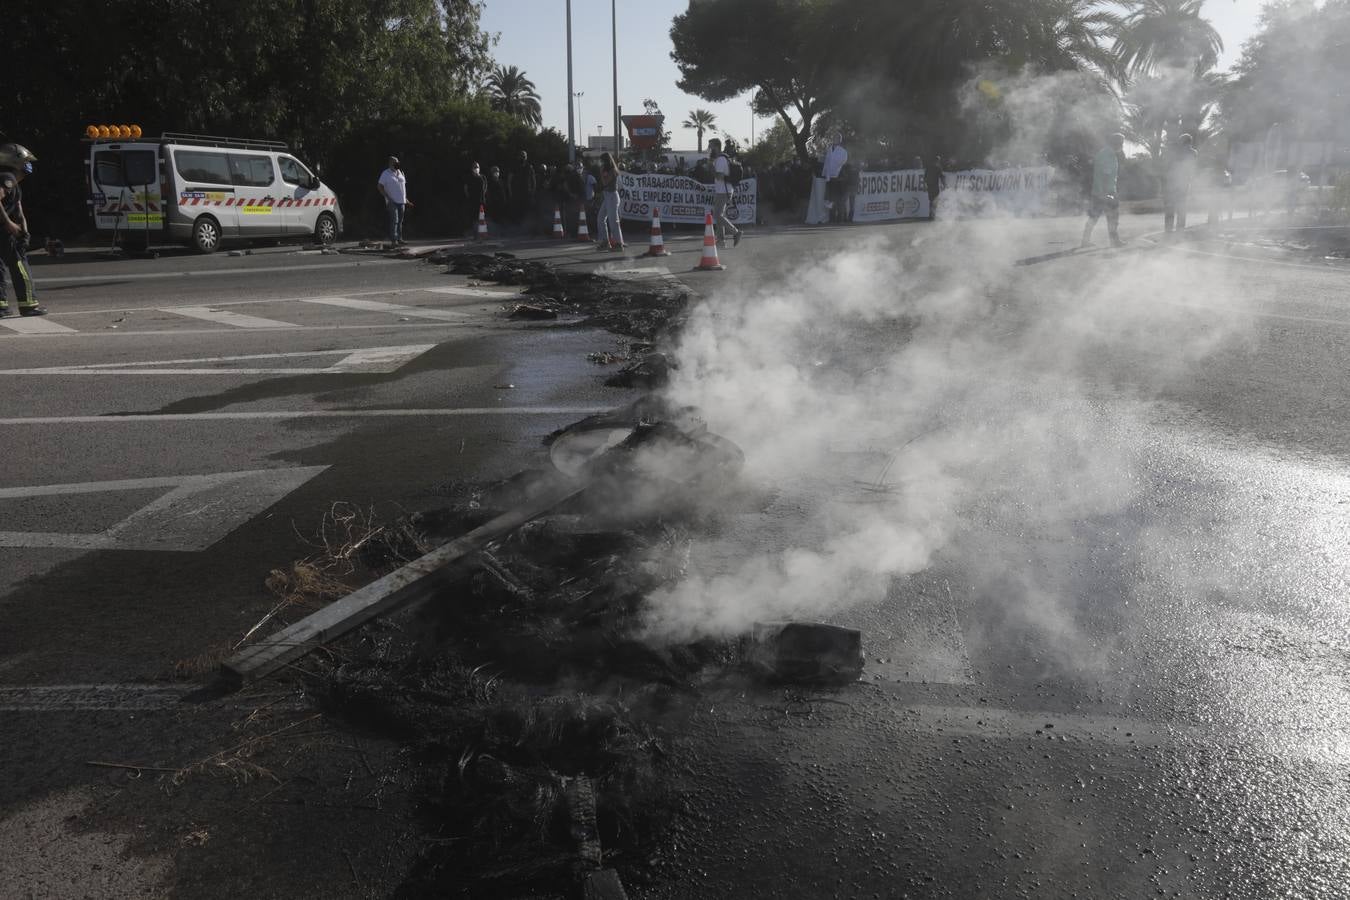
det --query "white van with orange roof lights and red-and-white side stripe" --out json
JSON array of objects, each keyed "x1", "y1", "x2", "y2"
[{"x1": 85, "y1": 132, "x2": 343, "y2": 254}]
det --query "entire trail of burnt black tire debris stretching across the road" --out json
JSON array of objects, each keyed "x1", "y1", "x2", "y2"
[{"x1": 216, "y1": 254, "x2": 861, "y2": 899}]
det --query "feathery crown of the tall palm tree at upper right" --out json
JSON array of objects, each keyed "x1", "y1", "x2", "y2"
[{"x1": 1112, "y1": 0, "x2": 1223, "y2": 76}]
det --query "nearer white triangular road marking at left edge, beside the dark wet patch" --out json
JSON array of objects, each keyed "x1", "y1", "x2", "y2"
[{"x1": 0, "y1": 466, "x2": 328, "y2": 552}]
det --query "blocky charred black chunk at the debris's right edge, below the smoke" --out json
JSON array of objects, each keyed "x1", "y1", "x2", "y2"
[{"x1": 747, "y1": 622, "x2": 863, "y2": 684}]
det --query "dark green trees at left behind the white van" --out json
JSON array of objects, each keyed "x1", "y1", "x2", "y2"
[{"x1": 0, "y1": 0, "x2": 569, "y2": 235}]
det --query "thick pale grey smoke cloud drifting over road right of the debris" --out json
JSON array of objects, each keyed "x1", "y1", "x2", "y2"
[{"x1": 634, "y1": 75, "x2": 1247, "y2": 655}]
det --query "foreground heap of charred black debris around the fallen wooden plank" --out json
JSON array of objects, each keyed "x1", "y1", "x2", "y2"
[{"x1": 240, "y1": 407, "x2": 772, "y2": 899}]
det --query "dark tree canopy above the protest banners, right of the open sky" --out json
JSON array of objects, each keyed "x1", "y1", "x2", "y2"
[{"x1": 671, "y1": 0, "x2": 1115, "y2": 167}]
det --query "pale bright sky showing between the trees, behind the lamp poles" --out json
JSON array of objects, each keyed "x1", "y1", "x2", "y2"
[{"x1": 482, "y1": 0, "x2": 1264, "y2": 150}]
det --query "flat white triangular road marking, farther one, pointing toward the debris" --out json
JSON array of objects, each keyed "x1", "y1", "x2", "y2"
[{"x1": 0, "y1": 344, "x2": 436, "y2": 375}]
